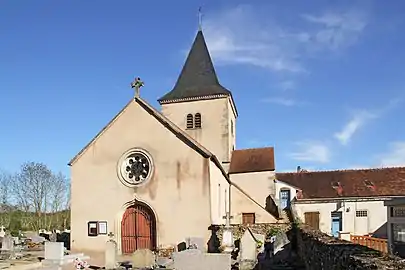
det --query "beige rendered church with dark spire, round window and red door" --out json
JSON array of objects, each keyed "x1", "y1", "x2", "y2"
[{"x1": 69, "y1": 30, "x2": 280, "y2": 254}]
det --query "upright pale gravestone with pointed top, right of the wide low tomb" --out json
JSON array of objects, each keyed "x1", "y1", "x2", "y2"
[{"x1": 239, "y1": 228, "x2": 258, "y2": 270}]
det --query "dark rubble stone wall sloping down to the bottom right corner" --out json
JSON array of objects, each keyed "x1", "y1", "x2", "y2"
[{"x1": 295, "y1": 225, "x2": 405, "y2": 270}]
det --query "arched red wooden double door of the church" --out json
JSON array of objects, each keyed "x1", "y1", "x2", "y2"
[{"x1": 121, "y1": 202, "x2": 156, "y2": 254}]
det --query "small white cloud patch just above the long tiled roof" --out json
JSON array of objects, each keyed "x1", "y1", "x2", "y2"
[{"x1": 289, "y1": 141, "x2": 331, "y2": 163}]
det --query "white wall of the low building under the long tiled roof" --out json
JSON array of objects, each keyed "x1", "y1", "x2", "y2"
[{"x1": 293, "y1": 200, "x2": 387, "y2": 235}]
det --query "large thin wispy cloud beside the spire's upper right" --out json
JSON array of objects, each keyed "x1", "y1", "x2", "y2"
[{"x1": 204, "y1": 5, "x2": 367, "y2": 73}]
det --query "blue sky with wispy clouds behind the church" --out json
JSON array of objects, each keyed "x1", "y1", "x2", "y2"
[{"x1": 0, "y1": 0, "x2": 405, "y2": 174}]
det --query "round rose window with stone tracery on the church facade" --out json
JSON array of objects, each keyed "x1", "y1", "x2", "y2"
[{"x1": 119, "y1": 150, "x2": 153, "y2": 186}]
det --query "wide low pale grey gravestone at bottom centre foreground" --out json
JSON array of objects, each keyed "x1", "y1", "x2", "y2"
[{"x1": 173, "y1": 249, "x2": 231, "y2": 270}]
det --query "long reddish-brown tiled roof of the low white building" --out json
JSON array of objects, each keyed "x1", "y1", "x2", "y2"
[{"x1": 276, "y1": 167, "x2": 405, "y2": 199}]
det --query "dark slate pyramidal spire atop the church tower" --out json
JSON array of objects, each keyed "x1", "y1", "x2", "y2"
[{"x1": 158, "y1": 30, "x2": 231, "y2": 104}]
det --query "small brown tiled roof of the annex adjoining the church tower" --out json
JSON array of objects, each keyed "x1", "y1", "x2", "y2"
[{"x1": 229, "y1": 147, "x2": 275, "y2": 174}]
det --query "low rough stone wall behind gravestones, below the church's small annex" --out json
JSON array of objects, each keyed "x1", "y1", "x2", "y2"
[{"x1": 217, "y1": 223, "x2": 291, "y2": 241}]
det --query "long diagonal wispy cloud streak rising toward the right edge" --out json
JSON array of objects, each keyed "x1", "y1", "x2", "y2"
[{"x1": 334, "y1": 99, "x2": 401, "y2": 145}]
